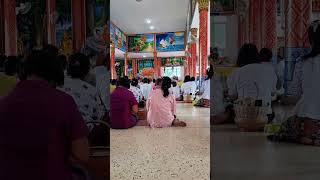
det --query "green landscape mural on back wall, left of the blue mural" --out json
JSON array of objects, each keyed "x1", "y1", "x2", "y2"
[{"x1": 128, "y1": 34, "x2": 155, "y2": 52}]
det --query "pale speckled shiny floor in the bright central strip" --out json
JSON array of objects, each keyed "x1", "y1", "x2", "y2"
[{"x1": 110, "y1": 104, "x2": 210, "y2": 180}]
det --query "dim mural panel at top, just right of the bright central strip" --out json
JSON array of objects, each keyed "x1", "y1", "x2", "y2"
[{"x1": 210, "y1": 0, "x2": 236, "y2": 14}]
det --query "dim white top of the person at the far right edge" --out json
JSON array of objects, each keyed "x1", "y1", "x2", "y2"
[{"x1": 294, "y1": 55, "x2": 320, "y2": 120}]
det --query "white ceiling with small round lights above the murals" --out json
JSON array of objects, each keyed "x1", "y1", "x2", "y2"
[{"x1": 110, "y1": 0, "x2": 190, "y2": 34}]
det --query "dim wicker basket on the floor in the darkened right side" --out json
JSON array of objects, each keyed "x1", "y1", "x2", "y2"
[{"x1": 234, "y1": 105, "x2": 268, "y2": 132}]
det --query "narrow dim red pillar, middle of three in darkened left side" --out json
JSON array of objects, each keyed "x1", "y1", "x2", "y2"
[{"x1": 46, "y1": 0, "x2": 56, "y2": 45}]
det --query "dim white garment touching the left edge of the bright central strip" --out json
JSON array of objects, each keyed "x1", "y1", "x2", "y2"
[{"x1": 94, "y1": 66, "x2": 110, "y2": 110}]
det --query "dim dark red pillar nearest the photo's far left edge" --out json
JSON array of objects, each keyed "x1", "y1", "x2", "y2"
[{"x1": 3, "y1": 0, "x2": 17, "y2": 56}]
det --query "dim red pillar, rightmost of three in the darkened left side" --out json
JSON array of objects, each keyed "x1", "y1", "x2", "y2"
[{"x1": 72, "y1": 0, "x2": 86, "y2": 51}]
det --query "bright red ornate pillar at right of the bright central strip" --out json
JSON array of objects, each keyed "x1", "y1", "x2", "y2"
[{"x1": 199, "y1": 0, "x2": 209, "y2": 76}]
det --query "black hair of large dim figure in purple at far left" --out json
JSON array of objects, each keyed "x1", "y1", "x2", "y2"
[{"x1": 22, "y1": 50, "x2": 64, "y2": 86}]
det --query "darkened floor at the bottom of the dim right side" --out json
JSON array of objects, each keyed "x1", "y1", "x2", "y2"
[{"x1": 210, "y1": 125, "x2": 320, "y2": 180}]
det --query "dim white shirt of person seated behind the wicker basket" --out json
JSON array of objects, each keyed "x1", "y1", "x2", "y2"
[{"x1": 227, "y1": 64, "x2": 277, "y2": 114}]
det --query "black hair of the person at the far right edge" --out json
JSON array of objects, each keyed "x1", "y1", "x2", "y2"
[{"x1": 303, "y1": 20, "x2": 320, "y2": 59}]
